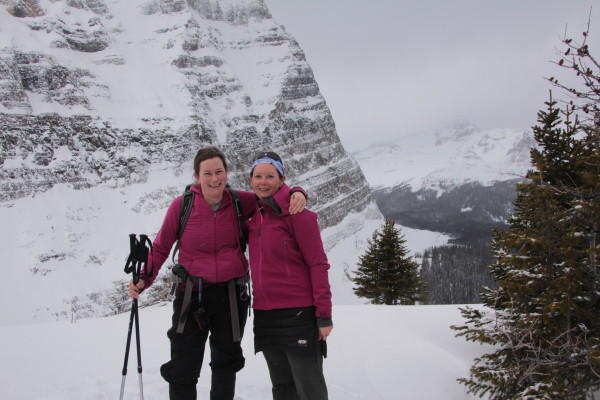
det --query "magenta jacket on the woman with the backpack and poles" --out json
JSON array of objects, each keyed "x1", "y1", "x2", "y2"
[{"x1": 141, "y1": 186, "x2": 256, "y2": 287}]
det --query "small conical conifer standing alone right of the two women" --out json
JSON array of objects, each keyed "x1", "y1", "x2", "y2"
[{"x1": 352, "y1": 219, "x2": 426, "y2": 305}]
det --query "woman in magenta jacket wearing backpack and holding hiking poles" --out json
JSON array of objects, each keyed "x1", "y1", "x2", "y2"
[{"x1": 129, "y1": 147, "x2": 306, "y2": 400}]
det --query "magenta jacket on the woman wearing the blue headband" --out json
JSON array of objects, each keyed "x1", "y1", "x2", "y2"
[{"x1": 248, "y1": 184, "x2": 331, "y2": 318}]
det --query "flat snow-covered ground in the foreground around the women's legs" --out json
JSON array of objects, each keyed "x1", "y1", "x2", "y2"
[{"x1": 0, "y1": 303, "x2": 489, "y2": 400}]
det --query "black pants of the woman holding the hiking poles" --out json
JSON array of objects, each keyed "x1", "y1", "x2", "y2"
[{"x1": 160, "y1": 286, "x2": 248, "y2": 400}]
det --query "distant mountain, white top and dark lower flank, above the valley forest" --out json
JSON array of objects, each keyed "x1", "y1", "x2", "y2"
[{"x1": 353, "y1": 122, "x2": 535, "y2": 242}]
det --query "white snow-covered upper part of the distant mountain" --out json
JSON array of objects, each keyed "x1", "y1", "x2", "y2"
[{"x1": 352, "y1": 121, "x2": 535, "y2": 192}]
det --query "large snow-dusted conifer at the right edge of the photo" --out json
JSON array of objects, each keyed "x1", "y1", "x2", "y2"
[{"x1": 453, "y1": 26, "x2": 600, "y2": 400}]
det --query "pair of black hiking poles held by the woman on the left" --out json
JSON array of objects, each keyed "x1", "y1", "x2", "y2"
[{"x1": 119, "y1": 233, "x2": 152, "y2": 400}]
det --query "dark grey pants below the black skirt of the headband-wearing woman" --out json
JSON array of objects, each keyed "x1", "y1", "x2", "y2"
[{"x1": 263, "y1": 347, "x2": 328, "y2": 400}]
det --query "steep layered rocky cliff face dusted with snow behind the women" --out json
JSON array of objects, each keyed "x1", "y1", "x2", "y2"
[{"x1": 0, "y1": 0, "x2": 372, "y2": 227}]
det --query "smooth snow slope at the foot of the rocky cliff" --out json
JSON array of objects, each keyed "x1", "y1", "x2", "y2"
[{"x1": 0, "y1": 178, "x2": 448, "y2": 326}]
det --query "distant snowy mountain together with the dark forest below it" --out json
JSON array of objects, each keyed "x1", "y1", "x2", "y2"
[{"x1": 353, "y1": 122, "x2": 535, "y2": 304}]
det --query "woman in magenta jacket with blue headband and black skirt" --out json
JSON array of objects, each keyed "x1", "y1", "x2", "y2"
[{"x1": 248, "y1": 152, "x2": 333, "y2": 400}]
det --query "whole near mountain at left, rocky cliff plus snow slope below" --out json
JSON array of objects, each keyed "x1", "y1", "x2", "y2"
[{"x1": 0, "y1": 0, "x2": 381, "y2": 324}]
